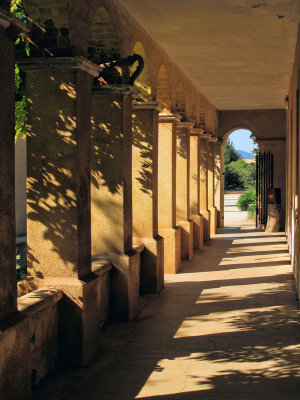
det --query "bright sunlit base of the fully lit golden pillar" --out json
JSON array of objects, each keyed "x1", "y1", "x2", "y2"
[{"x1": 159, "y1": 226, "x2": 181, "y2": 274}]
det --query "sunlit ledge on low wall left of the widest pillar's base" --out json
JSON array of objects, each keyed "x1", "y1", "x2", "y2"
[{"x1": 18, "y1": 288, "x2": 63, "y2": 315}]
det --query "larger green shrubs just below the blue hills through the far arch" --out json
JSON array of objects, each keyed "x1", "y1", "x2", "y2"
[{"x1": 225, "y1": 159, "x2": 256, "y2": 190}]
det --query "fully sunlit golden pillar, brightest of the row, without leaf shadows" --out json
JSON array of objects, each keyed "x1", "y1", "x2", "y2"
[{"x1": 158, "y1": 114, "x2": 181, "y2": 274}]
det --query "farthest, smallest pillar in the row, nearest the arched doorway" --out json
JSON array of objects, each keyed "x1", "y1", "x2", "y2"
[{"x1": 213, "y1": 140, "x2": 224, "y2": 228}]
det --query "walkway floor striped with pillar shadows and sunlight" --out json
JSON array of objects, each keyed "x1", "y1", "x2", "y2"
[{"x1": 33, "y1": 194, "x2": 300, "y2": 400}]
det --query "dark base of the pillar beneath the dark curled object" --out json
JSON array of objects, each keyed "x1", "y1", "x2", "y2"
[{"x1": 109, "y1": 247, "x2": 143, "y2": 321}]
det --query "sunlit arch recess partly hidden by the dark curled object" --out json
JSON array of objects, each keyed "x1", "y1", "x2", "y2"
[{"x1": 130, "y1": 42, "x2": 152, "y2": 101}]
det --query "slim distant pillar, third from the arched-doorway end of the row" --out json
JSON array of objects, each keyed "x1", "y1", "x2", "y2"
[{"x1": 199, "y1": 133, "x2": 211, "y2": 242}]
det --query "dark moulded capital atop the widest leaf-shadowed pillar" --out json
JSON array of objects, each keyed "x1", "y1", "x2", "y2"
[{"x1": 17, "y1": 57, "x2": 102, "y2": 77}]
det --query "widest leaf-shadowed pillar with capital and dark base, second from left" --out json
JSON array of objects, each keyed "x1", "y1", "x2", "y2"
[{"x1": 20, "y1": 57, "x2": 102, "y2": 365}]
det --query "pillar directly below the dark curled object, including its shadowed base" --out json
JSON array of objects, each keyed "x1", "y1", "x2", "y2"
[{"x1": 91, "y1": 85, "x2": 140, "y2": 320}]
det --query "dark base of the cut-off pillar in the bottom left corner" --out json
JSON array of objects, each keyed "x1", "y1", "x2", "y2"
[{"x1": 0, "y1": 312, "x2": 31, "y2": 400}]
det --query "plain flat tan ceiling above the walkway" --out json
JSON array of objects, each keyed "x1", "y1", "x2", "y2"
[{"x1": 119, "y1": 0, "x2": 300, "y2": 110}]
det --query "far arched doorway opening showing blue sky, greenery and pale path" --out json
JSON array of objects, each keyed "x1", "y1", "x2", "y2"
[{"x1": 224, "y1": 129, "x2": 258, "y2": 227}]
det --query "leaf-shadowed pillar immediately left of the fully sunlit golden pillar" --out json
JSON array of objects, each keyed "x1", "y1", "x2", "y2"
[{"x1": 132, "y1": 102, "x2": 164, "y2": 293}]
